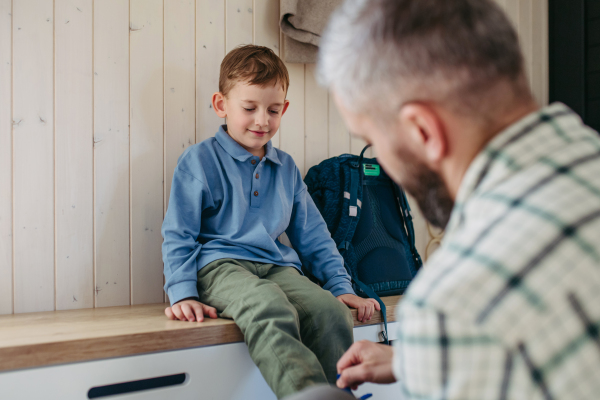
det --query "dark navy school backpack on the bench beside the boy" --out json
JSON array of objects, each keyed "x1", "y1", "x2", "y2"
[{"x1": 304, "y1": 146, "x2": 423, "y2": 343}]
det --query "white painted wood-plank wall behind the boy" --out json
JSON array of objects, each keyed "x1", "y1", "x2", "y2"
[{"x1": 0, "y1": 0, "x2": 548, "y2": 314}]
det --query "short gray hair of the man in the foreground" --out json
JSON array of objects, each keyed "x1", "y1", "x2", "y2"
[{"x1": 317, "y1": 0, "x2": 530, "y2": 114}]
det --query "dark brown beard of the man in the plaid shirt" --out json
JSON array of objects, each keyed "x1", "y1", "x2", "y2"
[{"x1": 400, "y1": 151, "x2": 454, "y2": 229}]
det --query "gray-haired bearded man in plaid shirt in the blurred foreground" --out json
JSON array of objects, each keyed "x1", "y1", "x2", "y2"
[{"x1": 284, "y1": 0, "x2": 600, "y2": 400}]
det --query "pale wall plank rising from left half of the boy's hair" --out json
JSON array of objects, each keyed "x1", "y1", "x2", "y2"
[{"x1": 225, "y1": 0, "x2": 254, "y2": 53}]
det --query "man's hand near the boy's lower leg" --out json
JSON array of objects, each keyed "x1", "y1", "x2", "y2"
[{"x1": 337, "y1": 340, "x2": 396, "y2": 390}]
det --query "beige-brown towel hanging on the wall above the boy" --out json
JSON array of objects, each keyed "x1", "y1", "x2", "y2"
[{"x1": 279, "y1": 0, "x2": 343, "y2": 63}]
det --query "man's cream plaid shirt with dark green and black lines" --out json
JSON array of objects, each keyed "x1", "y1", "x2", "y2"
[{"x1": 393, "y1": 103, "x2": 600, "y2": 400}]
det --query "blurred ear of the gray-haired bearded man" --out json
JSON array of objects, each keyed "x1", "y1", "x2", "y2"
[{"x1": 399, "y1": 103, "x2": 448, "y2": 166}]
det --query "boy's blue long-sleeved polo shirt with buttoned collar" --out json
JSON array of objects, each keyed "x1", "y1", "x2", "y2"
[{"x1": 162, "y1": 125, "x2": 354, "y2": 305}]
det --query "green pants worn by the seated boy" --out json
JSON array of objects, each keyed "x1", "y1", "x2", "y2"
[{"x1": 198, "y1": 259, "x2": 354, "y2": 398}]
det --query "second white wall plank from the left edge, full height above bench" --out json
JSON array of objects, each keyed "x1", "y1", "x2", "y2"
[{"x1": 13, "y1": 0, "x2": 55, "y2": 313}]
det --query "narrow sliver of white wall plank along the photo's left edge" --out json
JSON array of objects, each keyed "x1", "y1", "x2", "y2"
[{"x1": 0, "y1": 0, "x2": 13, "y2": 314}]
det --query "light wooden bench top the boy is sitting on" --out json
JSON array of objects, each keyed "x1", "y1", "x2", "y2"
[{"x1": 0, "y1": 296, "x2": 401, "y2": 371}]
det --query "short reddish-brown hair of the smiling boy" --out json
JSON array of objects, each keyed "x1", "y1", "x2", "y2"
[{"x1": 219, "y1": 44, "x2": 290, "y2": 97}]
